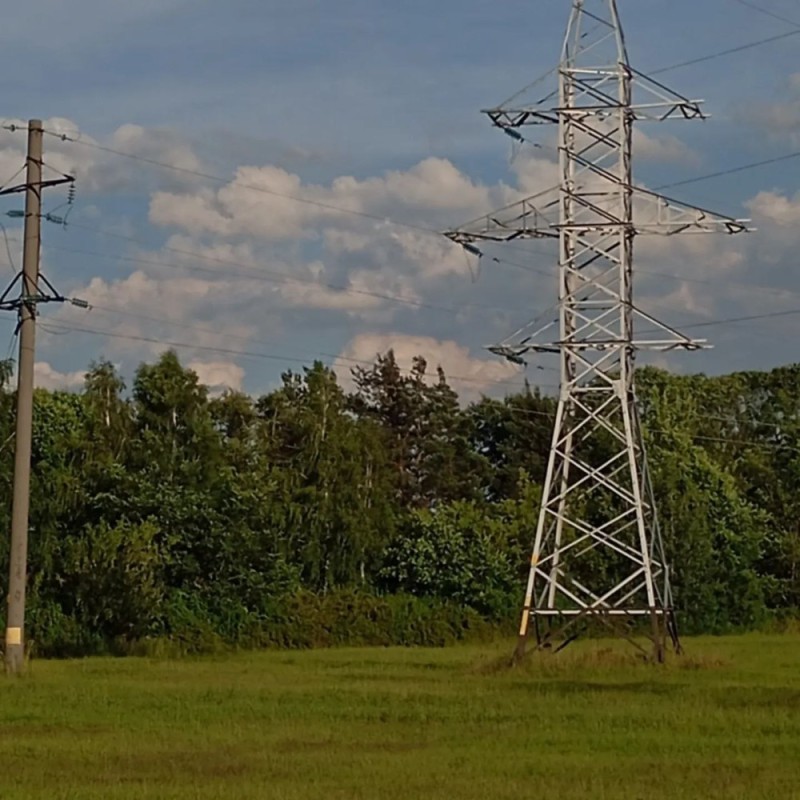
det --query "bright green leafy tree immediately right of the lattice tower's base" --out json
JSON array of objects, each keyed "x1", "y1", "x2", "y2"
[{"x1": 642, "y1": 374, "x2": 770, "y2": 632}]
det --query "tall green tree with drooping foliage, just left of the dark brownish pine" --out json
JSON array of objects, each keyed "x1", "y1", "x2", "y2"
[{"x1": 258, "y1": 363, "x2": 393, "y2": 590}]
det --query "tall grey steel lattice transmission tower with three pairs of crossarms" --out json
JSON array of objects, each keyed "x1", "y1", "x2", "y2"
[{"x1": 446, "y1": 0, "x2": 748, "y2": 661}]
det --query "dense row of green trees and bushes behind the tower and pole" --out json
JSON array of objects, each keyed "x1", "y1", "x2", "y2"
[{"x1": 0, "y1": 352, "x2": 800, "y2": 655}]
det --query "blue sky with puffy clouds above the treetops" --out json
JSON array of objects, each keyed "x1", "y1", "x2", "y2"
[{"x1": 0, "y1": 0, "x2": 800, "y2": 399}]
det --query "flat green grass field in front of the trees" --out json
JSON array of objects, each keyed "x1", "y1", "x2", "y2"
[{"x1": 0, "y1": 635, "x2": 800, "y2": 800}]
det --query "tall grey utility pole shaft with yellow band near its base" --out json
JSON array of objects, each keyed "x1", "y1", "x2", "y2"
[{"x1": 5, "y1": 119, "x2": 44, "y2": 675}]
